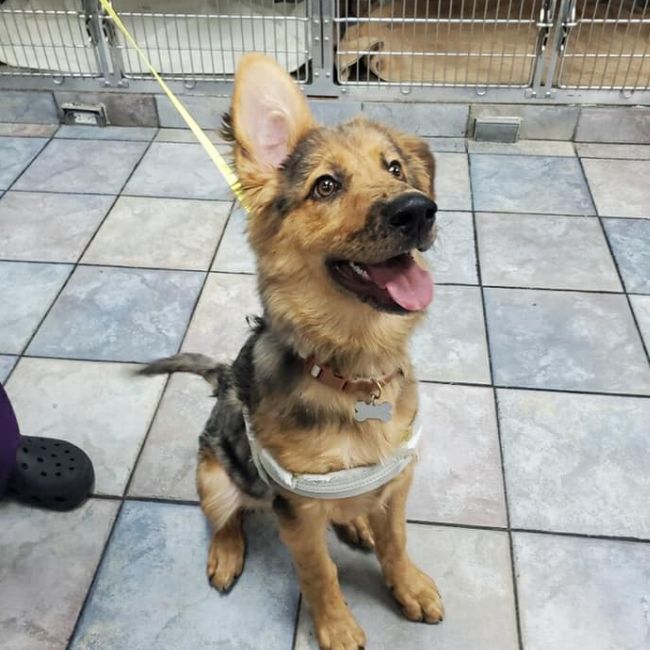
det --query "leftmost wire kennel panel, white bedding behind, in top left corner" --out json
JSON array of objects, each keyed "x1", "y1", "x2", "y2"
[{"x1": 0, "y1": 0, "x2": 100, "y2": 77}]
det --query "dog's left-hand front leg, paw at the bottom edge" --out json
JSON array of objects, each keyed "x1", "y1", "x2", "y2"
[{"x1": 274, "y1": 497, "x2": 366, "y2": 650}]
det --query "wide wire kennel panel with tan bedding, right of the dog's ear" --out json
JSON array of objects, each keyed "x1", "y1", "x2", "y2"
[{"x1": 335, "y1": 0, "x2": 549, "y2": 87}]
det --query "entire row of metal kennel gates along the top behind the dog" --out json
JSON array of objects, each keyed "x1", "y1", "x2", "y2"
[{"x1": 0, "y1": 0, "x2": 650, "y2": 104}]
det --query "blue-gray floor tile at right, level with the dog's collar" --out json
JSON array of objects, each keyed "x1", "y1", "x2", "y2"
[{"x1": 485, "y1": 289, "x2": 650, "y2": 395}]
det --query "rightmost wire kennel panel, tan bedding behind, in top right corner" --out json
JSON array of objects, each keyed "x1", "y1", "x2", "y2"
[{"x1": 557, "y1": 0, "x2": 650, "y2": 90}]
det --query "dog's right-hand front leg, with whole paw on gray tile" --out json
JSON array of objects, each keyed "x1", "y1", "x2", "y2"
[{"x1": 369, "y1": 467, "x2": 444, "y2": 623}]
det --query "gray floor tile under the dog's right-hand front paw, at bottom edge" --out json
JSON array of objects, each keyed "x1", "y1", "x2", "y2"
[{"x1": 295, "y1": 524, "x2": 518, "y2": 650}]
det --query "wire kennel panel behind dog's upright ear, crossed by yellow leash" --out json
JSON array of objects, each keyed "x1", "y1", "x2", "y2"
[{"x1": 113, "y1": 0, "x2": 311, "y2": 81}]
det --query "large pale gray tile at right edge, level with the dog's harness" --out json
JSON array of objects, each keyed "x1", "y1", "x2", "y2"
[{"x1": 498, "y1": 390, "x2": 650, "y2": 538}]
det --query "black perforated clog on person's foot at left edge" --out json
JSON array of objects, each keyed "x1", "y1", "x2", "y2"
[{"x1": 6, "y1": 436, "x2": 95, "y2": 510}]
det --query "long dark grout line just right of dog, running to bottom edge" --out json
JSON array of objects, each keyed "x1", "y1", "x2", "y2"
[{"x1": 468, "y1": 156, "x2": 524, "y2": 650}]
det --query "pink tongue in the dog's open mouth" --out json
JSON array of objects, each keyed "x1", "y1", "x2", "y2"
[{"x1": 366, "y1": 255, "x2": 433, "y2": 311}]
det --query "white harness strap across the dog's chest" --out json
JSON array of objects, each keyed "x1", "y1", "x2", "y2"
[{"x1": 244, "y1": 409, "x2": 422, "y2": 499}]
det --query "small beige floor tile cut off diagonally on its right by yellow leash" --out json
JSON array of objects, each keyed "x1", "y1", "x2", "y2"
[{"x1": 124, "y1": 142, "x2": 231, "y2": 200}]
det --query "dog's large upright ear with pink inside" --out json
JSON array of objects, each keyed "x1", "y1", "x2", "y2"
[{"x1": 232, "y1": 54, "x2": 314, "y2": 169}]
